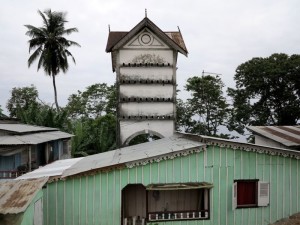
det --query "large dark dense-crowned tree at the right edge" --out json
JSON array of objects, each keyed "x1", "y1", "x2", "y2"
[{"x1": 228, "y1": 53, "x2": 300, "y2": 133}]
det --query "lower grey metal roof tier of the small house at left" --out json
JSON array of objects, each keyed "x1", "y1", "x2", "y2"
[{"x1": 0, "y1": 130, "x2": 74, "y2": 146}]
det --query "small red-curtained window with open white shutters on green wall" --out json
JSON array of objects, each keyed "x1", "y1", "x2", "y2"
[{"x1": 232, "y1": 179, "x2": 269, "y2": 209}]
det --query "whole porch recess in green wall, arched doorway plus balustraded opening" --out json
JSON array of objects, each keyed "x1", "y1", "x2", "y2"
[{"x1": 122, "y1": 182, "x2": 212, "y2": 225}]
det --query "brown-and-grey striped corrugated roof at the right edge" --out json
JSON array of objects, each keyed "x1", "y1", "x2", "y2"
[{"x1": 247, "y1": 126, "x2": 300, "y2": 146}]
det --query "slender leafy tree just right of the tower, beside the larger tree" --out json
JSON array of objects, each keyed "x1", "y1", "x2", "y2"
[{"x1": 183, "y1": 75, "x2": 229, "y2": 136}]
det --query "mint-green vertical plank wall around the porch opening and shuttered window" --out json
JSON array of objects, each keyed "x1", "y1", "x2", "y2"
[{"x1": 44, "y1": 146, "x2": 300, "y2": 225}]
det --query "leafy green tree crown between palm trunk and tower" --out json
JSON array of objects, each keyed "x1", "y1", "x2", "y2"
[{"x1": 66, "y1": 83, "x2": 117, "y2": 119}]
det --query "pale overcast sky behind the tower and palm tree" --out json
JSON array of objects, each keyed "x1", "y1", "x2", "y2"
[{"x1": 0, "y1": 0, "x2": 300, "y2": 115}]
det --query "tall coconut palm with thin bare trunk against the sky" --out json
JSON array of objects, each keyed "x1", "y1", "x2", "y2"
[{"x1": 25, "y1": 9, "x2": 80, "y2": 110}]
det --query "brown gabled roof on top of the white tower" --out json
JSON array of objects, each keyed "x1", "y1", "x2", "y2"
[{"x1": 106, "y1": 17, "x2": 188, "y2": 56}]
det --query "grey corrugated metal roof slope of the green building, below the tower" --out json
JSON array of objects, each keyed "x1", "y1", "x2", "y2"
[{"x1": 62, "y1": 134, "x2": 205, "y2": 177}]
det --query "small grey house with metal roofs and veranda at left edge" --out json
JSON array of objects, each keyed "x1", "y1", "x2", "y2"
[{"x1": 0, "y1": 121, "x2": 73, "y2": 179}]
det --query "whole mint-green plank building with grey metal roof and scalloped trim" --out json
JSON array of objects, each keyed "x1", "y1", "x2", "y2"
[{"x1": 19, "y1": 134, "x2": 300, "y2": 225}]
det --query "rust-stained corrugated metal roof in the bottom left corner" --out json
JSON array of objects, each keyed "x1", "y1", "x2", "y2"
[{"x1": 0, "y1": 178, "x2": 48, "y2": 214}]
